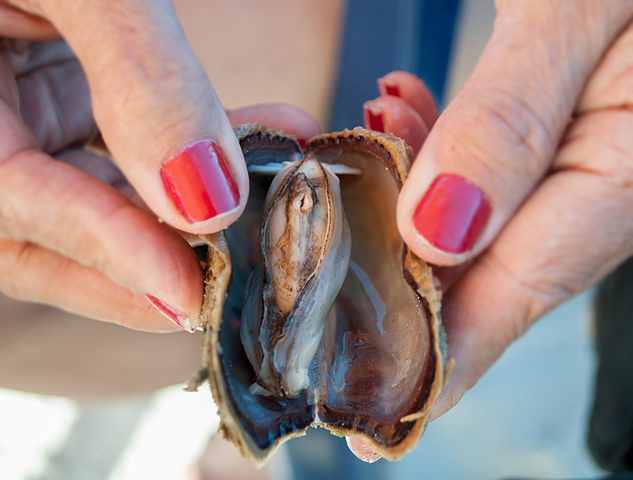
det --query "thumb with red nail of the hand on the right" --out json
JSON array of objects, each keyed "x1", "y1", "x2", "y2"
[{"x1": 398, "y1": 1, "x2": 631, "y2": 265}]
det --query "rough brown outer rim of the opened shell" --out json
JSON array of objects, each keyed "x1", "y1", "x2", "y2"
[{"x1": 198, "y1": 125, "x2": 446, "y2": 464}]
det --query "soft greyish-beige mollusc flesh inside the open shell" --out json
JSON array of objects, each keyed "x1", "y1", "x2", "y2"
[{"x1": 240, "y1": 158, "x2": 351, "y2": 398}]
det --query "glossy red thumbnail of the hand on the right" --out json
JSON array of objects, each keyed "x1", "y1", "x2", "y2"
[{"x1": 413, "y1": 174, "x2": 490, "y2": 254}]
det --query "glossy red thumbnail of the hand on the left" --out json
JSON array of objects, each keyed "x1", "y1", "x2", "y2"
[{"x1": 160, "y1": 140, "x2": 240, "y2": 223}]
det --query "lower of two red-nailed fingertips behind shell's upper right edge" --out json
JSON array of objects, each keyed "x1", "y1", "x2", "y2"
[{"x1": 363, "y1": 96, "x2": 429, "y2": 153}]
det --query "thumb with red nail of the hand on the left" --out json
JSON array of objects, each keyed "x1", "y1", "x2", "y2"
[{"x1": 34, "y1": 0, "x2": 248, "y2": 233}]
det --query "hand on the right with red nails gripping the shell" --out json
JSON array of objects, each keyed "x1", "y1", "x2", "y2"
[{"x1": 354, "y1": 0, "x2": 633, "y2": 462}]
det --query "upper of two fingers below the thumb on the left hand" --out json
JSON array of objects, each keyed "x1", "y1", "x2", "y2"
[{"x1": 0, "y1": 150, "x2": 202, "y2": 330}]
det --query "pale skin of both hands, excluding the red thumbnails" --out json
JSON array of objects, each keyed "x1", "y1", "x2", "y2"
[{"x1": 0, "y1": 0, "x2": 633, "y2": 464}]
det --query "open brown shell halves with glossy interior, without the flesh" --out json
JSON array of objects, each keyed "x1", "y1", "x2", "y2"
[{"x1": 200, "y1": 125, "x2": 446, "y2": 463}]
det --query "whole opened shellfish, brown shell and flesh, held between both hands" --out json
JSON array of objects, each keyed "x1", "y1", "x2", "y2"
[{"x1": 200, "y1": 125, "x2": 446, "y2": 463}]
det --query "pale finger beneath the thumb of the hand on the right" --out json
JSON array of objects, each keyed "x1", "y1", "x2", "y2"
[{"x1": 433, "y1": 108, "x2": 633, "y2": 416}]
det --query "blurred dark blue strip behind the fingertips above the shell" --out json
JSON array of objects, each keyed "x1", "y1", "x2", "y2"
[{"x1": 326, "y1": 0, "x2": 460, "y2": 130}]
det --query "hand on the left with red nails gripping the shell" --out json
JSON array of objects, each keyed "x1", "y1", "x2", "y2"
[{"x1": 0, "y1": 0, "x2": 318, "y2": 330}]
